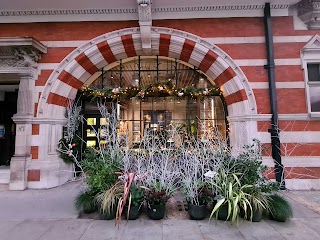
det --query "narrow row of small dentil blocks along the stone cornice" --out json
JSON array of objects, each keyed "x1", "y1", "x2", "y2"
[{"x1": 0, "y1": 4, "x2": 290, "y2": 16}]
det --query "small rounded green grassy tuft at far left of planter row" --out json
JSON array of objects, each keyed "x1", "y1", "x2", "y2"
[{"x1": 74, "y1": 191, "x2": 97, "y2": 213}]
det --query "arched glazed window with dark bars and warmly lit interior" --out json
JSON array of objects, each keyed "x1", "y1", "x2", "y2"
[{"x1": 81, "y1": 56, "x2": 228, "y2": 148}]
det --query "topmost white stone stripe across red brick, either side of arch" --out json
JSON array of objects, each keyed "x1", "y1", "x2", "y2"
[{"x1": 41, "y1": 35, "x2": 312, "y2": 48}]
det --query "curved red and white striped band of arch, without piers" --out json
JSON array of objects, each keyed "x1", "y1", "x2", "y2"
[{"x1": 37, "y1": 27, "x2": 257, "y2": 119}]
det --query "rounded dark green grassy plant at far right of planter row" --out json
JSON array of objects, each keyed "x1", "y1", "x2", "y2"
[{"x1": 269, "y1": 194, "x2": 292, "y2": 222}]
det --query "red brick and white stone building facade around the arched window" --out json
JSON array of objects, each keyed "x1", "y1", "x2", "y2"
[{"x1": 0, "y1": 0, "x2": 320, "y2": 190}]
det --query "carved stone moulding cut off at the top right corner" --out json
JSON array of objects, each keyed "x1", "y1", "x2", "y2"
[{"x1": 297, "y1": 0, "x2": 320, "y2": 30}]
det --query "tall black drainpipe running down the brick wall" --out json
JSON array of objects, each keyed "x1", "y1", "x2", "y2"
[{"x1": 264, "y1": 3, "x2": 286, "y2": 190}]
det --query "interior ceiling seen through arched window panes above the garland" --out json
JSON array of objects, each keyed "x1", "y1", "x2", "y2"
[{"x1": 92, "y1": 57, "x2": 210, "y2": 88}]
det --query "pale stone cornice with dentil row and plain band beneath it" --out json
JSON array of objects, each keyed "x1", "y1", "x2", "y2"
[{"x1": 0, "y1": 3, "x2": 290, "y2": 23}]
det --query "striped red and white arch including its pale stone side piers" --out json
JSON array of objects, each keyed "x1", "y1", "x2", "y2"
[{"x1": 26, "y1": 27, "x2": 257, "y2": 188}]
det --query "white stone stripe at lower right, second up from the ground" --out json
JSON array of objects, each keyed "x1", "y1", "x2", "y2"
[{"x1": 262, "y1": 156, "x2": 320, "y2": 168}]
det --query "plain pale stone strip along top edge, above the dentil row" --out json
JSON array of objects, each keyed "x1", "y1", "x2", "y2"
[{"x1": 0, "y1": 0, "x2": 300, "y2": 10}]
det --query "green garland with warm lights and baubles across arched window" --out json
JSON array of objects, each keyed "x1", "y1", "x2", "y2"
[{"x1": 81, "y1": 81, "x2": 222, "y2": 100}]
